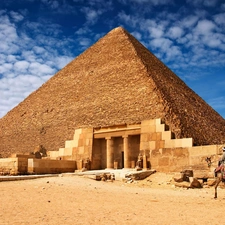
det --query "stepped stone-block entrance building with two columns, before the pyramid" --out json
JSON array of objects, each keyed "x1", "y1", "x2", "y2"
[{"x1": 49, "y1": 119, "x2": 196, "y2": 170}]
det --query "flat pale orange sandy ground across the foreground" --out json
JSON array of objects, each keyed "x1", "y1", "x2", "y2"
[{"x1": 0, "y1": 173, "x2": 225, "y2": 225}]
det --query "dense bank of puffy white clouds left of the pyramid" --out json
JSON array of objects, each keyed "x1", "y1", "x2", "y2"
[{"x1": 0, "y1": 8, "x2": 73, "y2": 117}]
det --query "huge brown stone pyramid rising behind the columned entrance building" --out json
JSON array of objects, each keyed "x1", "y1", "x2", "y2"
[{"x1": 0, "y1": 27, "x2": 225, "y2": 157}]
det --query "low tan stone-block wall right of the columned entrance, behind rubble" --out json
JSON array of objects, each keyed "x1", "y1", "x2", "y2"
[{"x1": 150, "y1": 145, "x2": 222, "y2": 177}]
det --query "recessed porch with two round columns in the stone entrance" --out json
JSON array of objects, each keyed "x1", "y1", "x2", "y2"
[{"x1": 93, "y1": 124, "x2": 141, "y2": 169}]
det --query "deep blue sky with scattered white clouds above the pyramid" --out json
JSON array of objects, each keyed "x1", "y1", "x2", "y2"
[{"x1": 0, "y1": 0, "x2": 225, "y2": 118}]
